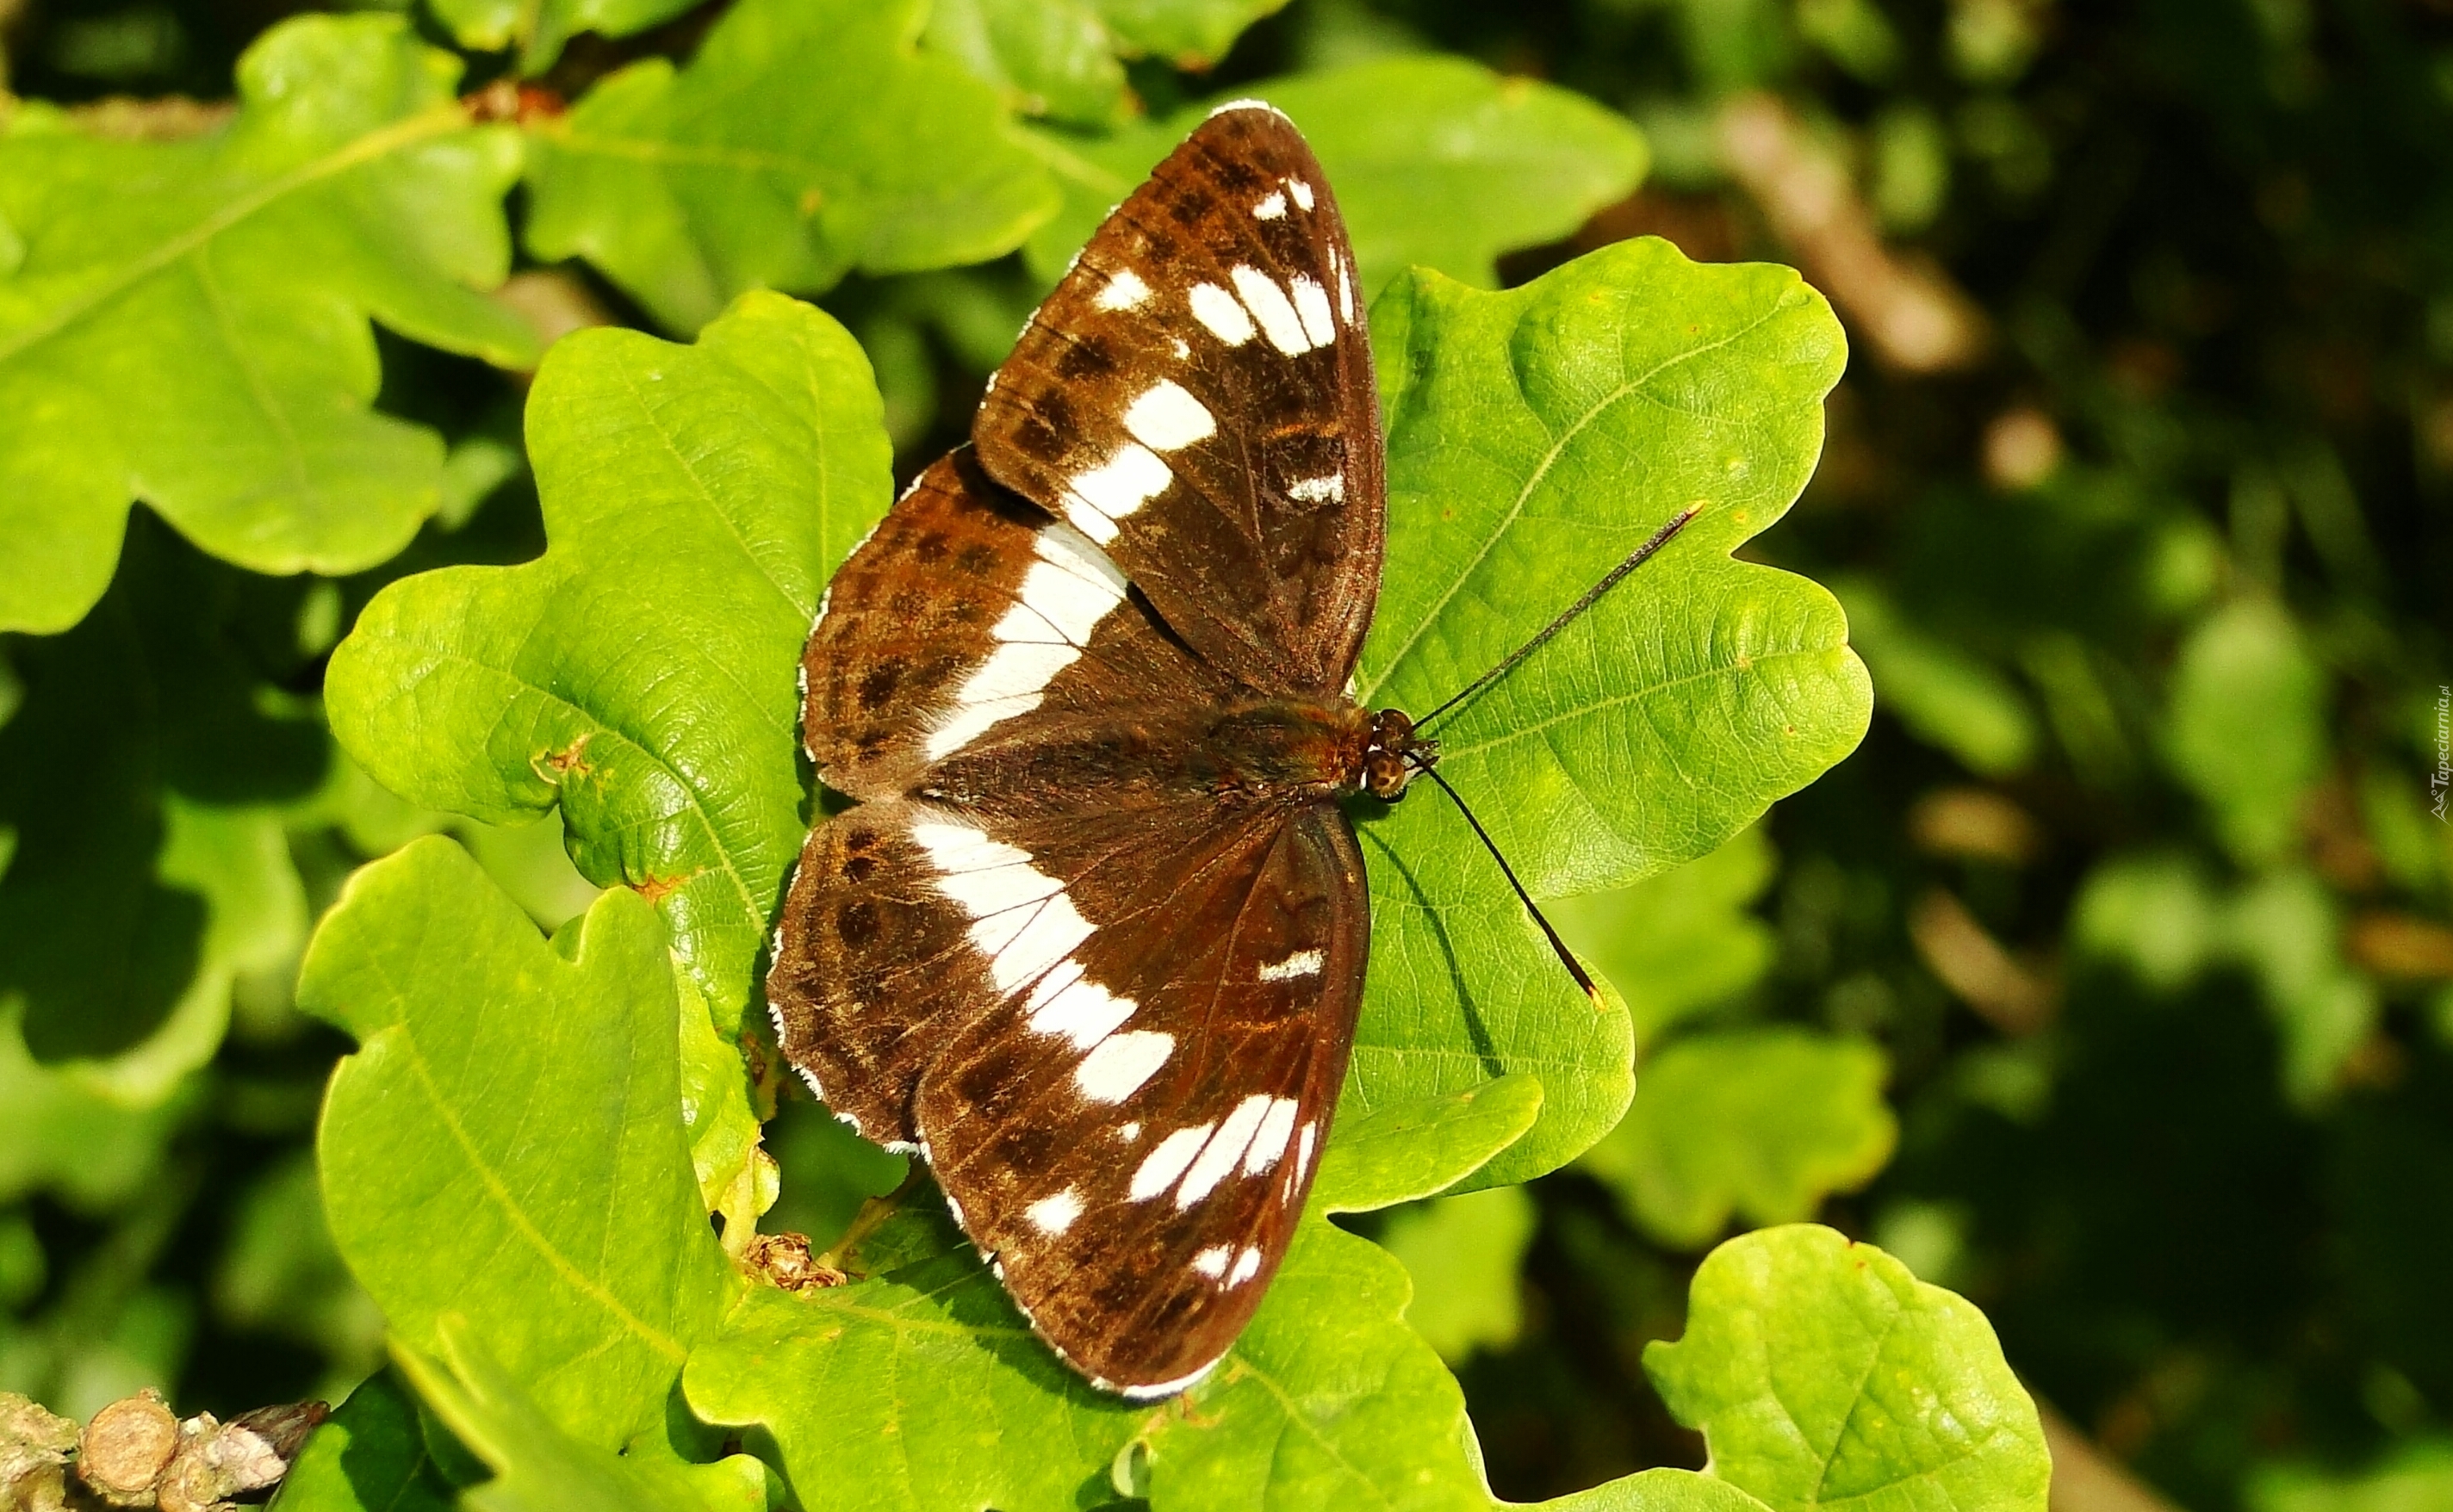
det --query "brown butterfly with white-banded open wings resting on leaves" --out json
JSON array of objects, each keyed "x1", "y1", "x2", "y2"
[{"x1": 767, "y1": 103, "x2": 1666, "y2": 1397}]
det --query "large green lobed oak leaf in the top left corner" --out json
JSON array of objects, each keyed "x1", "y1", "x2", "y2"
[{"x1": 0, "y1": 15, "x2": 535, "y2": 632}]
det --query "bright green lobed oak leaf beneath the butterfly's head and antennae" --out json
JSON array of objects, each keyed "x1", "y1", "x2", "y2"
[{"x1": 1349, "y1": 240, "x2": 1869, "y2": 1186}]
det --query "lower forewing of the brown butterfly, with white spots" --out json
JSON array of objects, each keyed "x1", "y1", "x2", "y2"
[{"x1": 917, "y1": 802, "x2": 1369, "y2": 1397}]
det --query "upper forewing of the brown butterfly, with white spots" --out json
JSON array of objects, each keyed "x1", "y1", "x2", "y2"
[{"x1": 972, "y1": 103, "x2": 1386, "y2": 698}]
